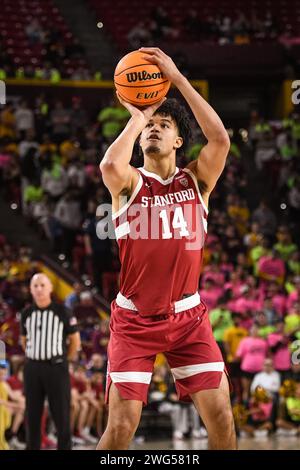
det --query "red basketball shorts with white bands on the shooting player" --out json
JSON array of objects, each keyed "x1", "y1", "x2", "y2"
[{"x1": 106, "y1": 301, "x2": 224, "y2": 404}]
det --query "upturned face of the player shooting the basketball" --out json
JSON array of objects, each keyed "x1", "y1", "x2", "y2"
[{"x1": 140, "y1": 114, "x2": 183, "y2": 156}]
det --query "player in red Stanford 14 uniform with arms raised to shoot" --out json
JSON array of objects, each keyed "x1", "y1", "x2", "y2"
[{"x1": 97, "y1": 48, "x2": 236, "y2": 450}]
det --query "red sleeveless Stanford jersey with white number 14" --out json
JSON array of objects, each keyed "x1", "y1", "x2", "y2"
[{"x1": 112, "y1": 168, "x2": 208, "y2": 316}]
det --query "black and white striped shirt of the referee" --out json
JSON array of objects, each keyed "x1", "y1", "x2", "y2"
[{"x1": 21, "y1": 302, "x2": 78, "y2": 361}]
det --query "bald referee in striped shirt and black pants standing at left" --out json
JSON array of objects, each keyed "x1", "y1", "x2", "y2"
[{"x1": 21, "y1": 273, "x2": 80, "y2": 450}]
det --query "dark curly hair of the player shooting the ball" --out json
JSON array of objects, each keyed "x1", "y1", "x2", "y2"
[{"x1": 154, "y1": 98, "x2": 192, "y2": 156}]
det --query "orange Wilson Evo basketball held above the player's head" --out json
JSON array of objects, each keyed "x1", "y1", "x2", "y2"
[{"x1": 114, "y1": 51, "x2": 171, "y2": 107}]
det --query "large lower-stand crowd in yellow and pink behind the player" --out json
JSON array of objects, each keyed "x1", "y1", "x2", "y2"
[{"x1": 0, "y1": 95, "x2": 300, "y2": 447}]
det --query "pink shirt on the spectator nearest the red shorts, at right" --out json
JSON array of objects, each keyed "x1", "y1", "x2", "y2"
[{"x1": 236, "y1": 336, "x2": 268, "y2": 373}]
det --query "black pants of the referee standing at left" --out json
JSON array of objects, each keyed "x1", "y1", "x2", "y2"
[{"x1": 24, "y1": 360, "x2": 71, "y2": 450}]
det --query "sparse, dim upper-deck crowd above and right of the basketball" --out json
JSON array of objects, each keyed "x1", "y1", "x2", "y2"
[{"x1": 127, "y1": 6, "x2": 289, "y2": 49}]
